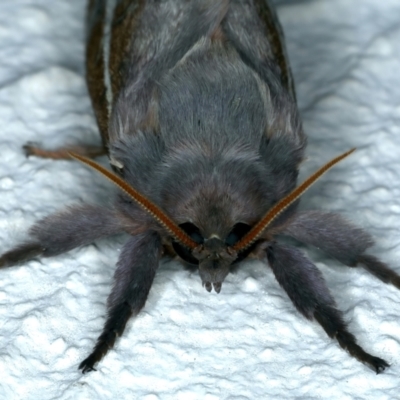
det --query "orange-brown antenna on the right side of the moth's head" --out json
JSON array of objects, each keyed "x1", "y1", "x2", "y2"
[{"x1": 232, "y1": 149, "x2": 355, "y2": 252}]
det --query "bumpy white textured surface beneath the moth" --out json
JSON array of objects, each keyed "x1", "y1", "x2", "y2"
[{"x1": 0, "y1": 0, "x2": 400, "y2": 400}]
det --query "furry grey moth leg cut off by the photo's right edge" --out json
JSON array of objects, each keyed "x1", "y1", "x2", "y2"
[{"x1": 282, "y1": 211, "x2": 400, "y2": 289}]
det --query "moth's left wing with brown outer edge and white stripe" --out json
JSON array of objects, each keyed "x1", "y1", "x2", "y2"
[{"x1": 86, "y1": 0, "x2": 229, "y2": 146}]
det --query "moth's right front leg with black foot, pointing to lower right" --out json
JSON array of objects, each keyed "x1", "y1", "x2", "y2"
[{"x1": 266, "y1": 243, "x2": 389, "y2": 374}]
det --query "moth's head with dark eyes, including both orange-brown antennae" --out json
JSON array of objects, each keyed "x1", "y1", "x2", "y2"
[{"x1": 71, "y1": 149, "x2": 355, "y2": 293}]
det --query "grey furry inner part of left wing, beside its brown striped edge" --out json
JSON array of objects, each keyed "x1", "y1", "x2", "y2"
[{"x1": 110, "y1": 0, "x2": 228, "y2": 142}]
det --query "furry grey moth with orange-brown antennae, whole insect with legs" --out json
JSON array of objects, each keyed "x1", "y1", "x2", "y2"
[{"x1": 0, "y1": 0, "x2": 400, "y2": 373}]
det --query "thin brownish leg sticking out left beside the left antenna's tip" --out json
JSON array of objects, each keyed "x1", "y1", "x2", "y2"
[{"x1": 23, "y1": 143, "x2": 108, "y2": 160}]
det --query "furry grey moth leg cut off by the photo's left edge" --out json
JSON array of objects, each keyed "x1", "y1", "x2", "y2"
[{"x1": 0, "y1": 205, "x2": 121, "y2": 268}]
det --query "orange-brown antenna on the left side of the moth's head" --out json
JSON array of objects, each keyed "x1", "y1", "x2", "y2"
[{"x1": 69, "y1": 153, "x2": 198, "y2": 249}]
